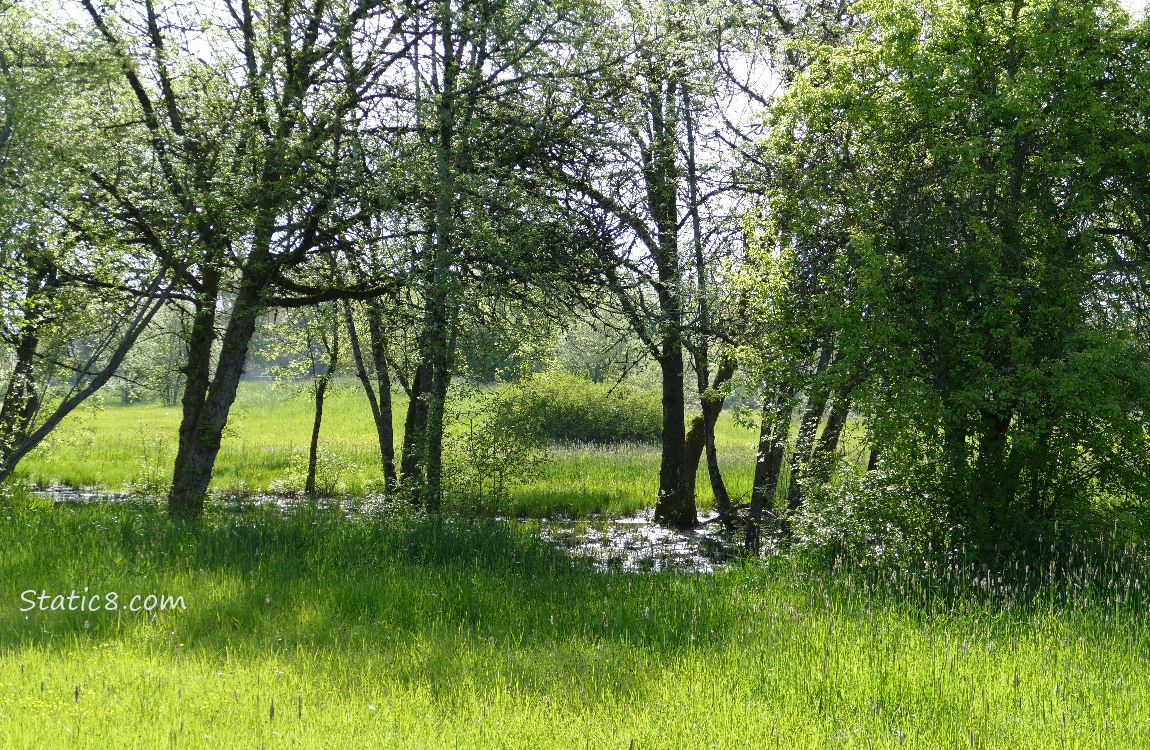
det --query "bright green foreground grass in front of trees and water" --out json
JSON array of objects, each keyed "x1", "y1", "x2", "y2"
[{"x1": 0, "y1": 497, "x2": 1150, "y2": 750}]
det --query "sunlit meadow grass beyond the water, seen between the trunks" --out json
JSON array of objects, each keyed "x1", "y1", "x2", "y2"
[{"x1": 21, "y1": 382, "x2": 756, "y2": 516}]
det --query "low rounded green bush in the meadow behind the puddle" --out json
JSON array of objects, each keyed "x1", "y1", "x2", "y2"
[{"x1": 507, "y1": 372, "x2": 662, "y2": 444}]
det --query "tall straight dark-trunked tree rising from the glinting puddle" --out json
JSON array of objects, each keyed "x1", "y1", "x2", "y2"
[{"x1": 557, "y1": 3, "x2": 697, "y2": 529}]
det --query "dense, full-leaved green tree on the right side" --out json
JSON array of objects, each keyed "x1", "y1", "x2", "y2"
[{"x1": 767, "y1": 0, "x2": 1150, "y2": 545}]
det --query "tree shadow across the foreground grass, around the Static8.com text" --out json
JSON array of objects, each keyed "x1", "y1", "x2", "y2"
[{"x1": 0, "y1": 503, "x2": 739, "y2": 689}]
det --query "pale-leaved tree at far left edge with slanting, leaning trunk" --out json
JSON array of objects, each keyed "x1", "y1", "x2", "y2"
[{"x1": 0, "y1": 8, "x2": 175, "y2": 480}]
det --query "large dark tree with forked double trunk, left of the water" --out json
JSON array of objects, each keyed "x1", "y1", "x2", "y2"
[{"x1": 81, "y1": 0, "x2": 414, "y2": 518}]
